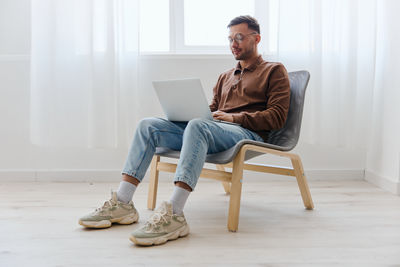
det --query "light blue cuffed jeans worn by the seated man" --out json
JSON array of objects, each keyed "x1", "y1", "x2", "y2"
[{"x1": 122, "y1": 118, "x2": 263, "y2": 189}]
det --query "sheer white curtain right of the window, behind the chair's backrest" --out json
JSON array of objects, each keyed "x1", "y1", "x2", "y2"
[{"x1": 270, "y1": 0, "x2": 377, "y2": 148}]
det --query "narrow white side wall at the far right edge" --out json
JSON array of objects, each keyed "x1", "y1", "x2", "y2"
[{"x1": 366, "y1": 0, "x2": 400, "y2": 182}]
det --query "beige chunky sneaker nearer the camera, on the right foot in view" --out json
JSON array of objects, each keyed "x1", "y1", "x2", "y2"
[{"x1": 129, "y1": 201, "x2": 189, "y2": 246}]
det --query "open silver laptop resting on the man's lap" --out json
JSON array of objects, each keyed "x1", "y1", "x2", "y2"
[{"x1": 153, "y1": 78, "x2": 239, "y2": 125}]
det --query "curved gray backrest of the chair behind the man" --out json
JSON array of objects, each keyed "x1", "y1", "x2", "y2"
[{"x1": 267, "y1": 71, "x2": 310, "y2": 151}]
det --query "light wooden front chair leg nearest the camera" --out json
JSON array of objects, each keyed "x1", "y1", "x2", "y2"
[{"x1": 228, "y1": 149, "x2": 246, "y2": 232}]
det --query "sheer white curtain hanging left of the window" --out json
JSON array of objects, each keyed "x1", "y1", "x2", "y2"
[{"x1": 30, "y1": 0, "x2": 139, "y2": 148}]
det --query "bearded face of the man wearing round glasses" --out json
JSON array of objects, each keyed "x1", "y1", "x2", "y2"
[{"x1": 228, "y1": 23, "x2": 260, "y2": 60}]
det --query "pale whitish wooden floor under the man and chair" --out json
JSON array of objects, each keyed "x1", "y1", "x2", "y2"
[{"x1": 0, "y1": 178, "x2": 400, "y2": 266}]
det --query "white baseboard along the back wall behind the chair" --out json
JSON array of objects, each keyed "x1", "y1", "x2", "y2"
[{"x1": 0, "y1": 169, "x2": 364, "y2": 182}]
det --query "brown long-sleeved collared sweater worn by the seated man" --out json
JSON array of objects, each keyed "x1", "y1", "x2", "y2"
[{"x1": 210, "y1": 56, "x2": 290, "y2": 141}]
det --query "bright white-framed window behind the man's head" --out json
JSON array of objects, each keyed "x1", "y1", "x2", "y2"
[{"x1": 140, "y1": 0, "x2": 279, "y2": 54}]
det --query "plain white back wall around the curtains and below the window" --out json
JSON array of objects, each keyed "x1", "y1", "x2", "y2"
[{"x1": 0, "y1": 0, "x2": 372, "y2": 184}]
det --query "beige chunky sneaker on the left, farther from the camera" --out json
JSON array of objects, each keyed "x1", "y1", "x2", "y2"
[{"x1": 79, "y1": 192, "x2": 139, "y2": 228}]
